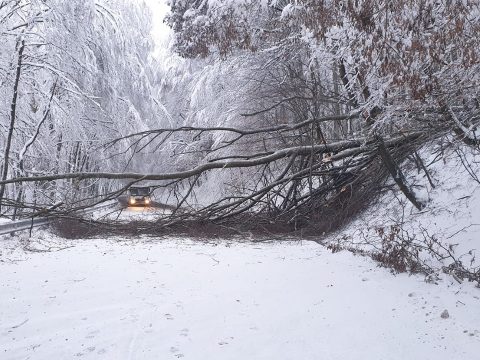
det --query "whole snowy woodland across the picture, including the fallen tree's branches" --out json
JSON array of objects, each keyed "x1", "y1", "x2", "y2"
[{"x1": 0, "y1": 0, "x2": 480, "y2": 233}]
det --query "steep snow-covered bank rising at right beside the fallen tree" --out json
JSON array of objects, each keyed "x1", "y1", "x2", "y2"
[{"x1": 327, "y1": 145, "x2": 480, "y2": 268}]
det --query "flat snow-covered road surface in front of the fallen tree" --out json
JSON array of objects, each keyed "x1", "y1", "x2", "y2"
[{"x1": 0, "y1": 239, "x2": 480, "y2": 360}]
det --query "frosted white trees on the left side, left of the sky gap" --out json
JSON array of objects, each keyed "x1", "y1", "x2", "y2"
[{"x1": 0, "y1": 0, "x2": 161, "y2": 217}]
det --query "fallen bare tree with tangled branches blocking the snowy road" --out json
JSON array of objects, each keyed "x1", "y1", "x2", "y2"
[{"x1": 0, "y1": 121, "x2": 425, "y2": 236}]
